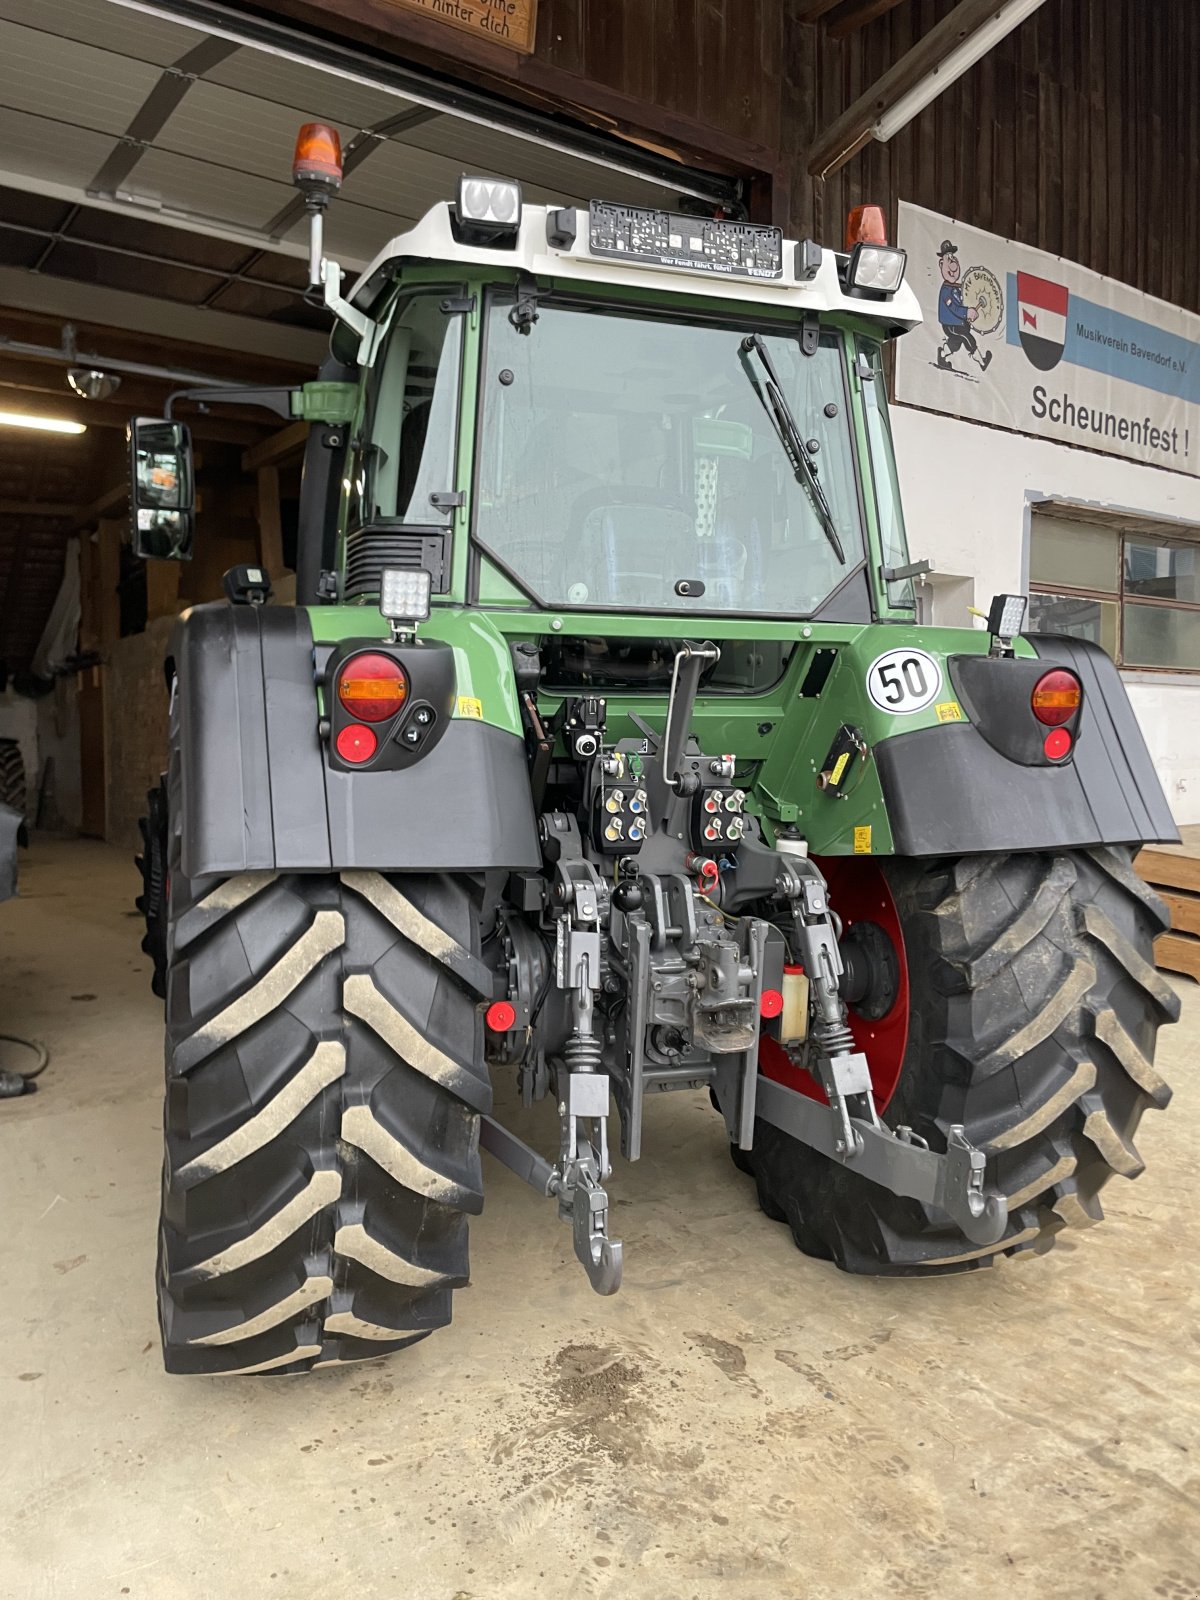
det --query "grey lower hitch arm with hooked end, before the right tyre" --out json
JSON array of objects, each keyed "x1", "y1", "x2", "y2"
[{"x1": 758, "y1": 1078, "x2": 1008, "y2": 1246}]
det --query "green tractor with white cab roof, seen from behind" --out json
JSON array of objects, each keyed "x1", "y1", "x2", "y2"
[{"x1": 131, "y1": 128, "x2": 1178, "y2": 1374}]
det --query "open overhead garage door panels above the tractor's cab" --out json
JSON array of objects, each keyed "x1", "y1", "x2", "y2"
[{"x1": 0, "y1": 0, "x2": 720, "y2": 308}]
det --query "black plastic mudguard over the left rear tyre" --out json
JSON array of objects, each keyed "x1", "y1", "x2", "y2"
[{"x1": 171, "y1": 603, "x2": 541, "y2": 878}]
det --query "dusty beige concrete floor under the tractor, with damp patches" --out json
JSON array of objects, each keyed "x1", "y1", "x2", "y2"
[{"x1": 0, "y1": 843, "x2": 1200, "y2": 1600}]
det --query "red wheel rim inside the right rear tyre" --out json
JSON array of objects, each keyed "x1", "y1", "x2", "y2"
[{"x1": 758, "y1": 856, "x2": 909, "y2": 1110}]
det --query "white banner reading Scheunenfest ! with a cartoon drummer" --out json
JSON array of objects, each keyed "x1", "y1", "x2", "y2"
[{"x1": 896, "y1": 202, "x2": 1200, "y2": 475}]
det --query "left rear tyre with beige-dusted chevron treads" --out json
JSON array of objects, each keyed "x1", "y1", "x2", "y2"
[{"x1": 158, "y1": 867, "x2": 491, "y2": 1374}]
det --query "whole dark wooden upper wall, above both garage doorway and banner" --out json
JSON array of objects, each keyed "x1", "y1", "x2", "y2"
[{"x1": 249, "y1": 0, "x2": 1200, "y2": 309}]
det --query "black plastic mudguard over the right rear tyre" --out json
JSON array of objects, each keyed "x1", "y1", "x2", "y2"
[{"x1": 875, "y1": 634, "x2": 1179, "y2": 856}]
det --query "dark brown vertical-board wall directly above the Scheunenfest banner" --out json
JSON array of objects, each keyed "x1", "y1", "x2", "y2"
[{"x1": 781, "y1": 0, "x2": 1200, "y2": 310}]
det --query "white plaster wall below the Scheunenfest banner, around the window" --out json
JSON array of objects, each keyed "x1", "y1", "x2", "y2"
[{"x1": 891, "y1": 405, "x2": 1200, "y2": 822}]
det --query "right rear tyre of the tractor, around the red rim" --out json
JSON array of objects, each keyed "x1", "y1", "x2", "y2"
[{"x1": 739, "y1": 848, "x2": 1179, "y2": 1275}]
